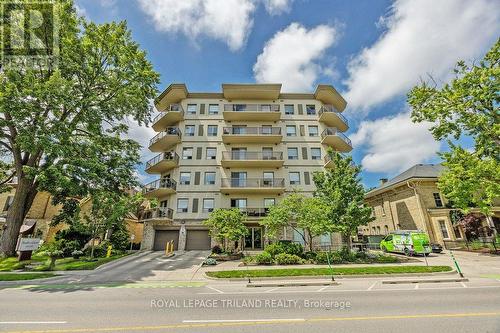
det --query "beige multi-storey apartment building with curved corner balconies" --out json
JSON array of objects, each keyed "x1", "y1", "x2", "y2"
[{"x1": 142, "y1": 84, "x2": 352, "y2": 250}]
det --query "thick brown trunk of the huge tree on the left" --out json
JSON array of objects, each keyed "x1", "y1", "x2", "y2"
[{"x1": 0, "y1": 178, "x2": 37, "y2": 257}]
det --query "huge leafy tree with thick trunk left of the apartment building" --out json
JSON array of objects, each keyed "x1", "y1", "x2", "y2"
[{"x1": 0, "y1": 0, "x2": 159, "y2": 255}]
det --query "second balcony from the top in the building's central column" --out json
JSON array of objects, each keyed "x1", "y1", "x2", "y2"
[{"x1": 222, "y1": 127, "x2": 282, "y2": 144}]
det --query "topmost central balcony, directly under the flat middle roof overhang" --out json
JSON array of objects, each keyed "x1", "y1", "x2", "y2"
[{"x1": 223, "y1": 104, "x2": 281, "y2": 121}]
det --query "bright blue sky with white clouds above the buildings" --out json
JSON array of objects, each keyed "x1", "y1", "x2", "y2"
[{"x1": 75, "y1": 0, "x2": 500, "y2": 188}]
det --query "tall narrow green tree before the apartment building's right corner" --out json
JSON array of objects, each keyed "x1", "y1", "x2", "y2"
[{"x1": 313, "y1": 150, "x2": 373, "y2": 249}]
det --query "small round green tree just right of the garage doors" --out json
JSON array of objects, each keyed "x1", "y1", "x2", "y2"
[{"x1": 203, "y1": 208, "x2": 248, "y2": 251}]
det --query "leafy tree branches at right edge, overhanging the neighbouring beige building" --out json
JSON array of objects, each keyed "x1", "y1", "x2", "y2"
[{"x1": 408, "y1": 40, "x2": 500, "y2": 216}]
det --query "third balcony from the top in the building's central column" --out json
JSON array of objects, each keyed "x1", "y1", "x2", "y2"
[{"x1": 221, "y1": 151, "x2": 285, "y2": 168}]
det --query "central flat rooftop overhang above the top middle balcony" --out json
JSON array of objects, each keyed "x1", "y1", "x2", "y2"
[{"x1": 222, "y1": 83, "x2": 281, "y2": 100}]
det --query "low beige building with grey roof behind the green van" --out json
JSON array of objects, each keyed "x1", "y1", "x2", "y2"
[{"x1": 358, "y1": 164, "x2": 500, "y2": 247}]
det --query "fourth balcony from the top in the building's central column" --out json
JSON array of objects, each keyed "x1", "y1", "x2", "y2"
[{"x1": 220, "y1": 178, "x2": 285, "y2": 194}]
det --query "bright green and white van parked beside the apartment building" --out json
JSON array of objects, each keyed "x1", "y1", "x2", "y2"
[{"x1": 380, "y1": 230, "x2": 432, "y2": 256}]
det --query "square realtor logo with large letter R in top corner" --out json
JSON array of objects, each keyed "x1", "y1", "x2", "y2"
[{"x1": 0, "y1": 0, "x2": 59, "y2": 68}]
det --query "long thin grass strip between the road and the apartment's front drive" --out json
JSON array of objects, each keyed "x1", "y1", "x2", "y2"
[{"x1": 206, "y1": 266, "x2": 451, "y2": 279}]
